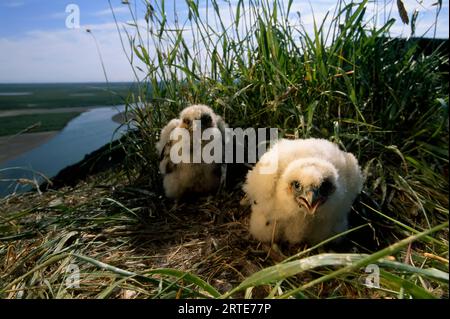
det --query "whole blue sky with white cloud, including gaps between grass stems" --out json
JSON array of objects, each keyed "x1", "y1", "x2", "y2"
[{"x1": 0, "y1": 0, "x2": 449, "y2": 83}]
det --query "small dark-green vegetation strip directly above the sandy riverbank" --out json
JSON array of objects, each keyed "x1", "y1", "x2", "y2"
[{"x1": 0, "y1": 112, "x2": 80, "y2": 136}]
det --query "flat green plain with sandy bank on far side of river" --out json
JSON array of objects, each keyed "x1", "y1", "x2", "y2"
[{"x1": 0, "y1": 82, "x2": 134, "y2": 162}]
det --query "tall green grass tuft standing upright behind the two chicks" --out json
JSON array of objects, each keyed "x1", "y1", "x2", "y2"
[{"x1": 112, "y1": 0, "x2": 448, "y2": 300}]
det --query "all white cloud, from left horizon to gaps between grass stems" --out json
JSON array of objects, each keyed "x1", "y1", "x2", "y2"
[{"x1": 0, "y1": 0, "x2": 448, "y2": 82}]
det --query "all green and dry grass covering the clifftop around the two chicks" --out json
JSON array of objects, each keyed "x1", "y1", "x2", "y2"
[{"x1": 0, "y1": 0, "x2": 449, "y2": 298}]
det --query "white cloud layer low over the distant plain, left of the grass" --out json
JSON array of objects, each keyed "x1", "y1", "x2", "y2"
[{"x1": 0, "y1": 23, "x2": 142, "y2": 82}]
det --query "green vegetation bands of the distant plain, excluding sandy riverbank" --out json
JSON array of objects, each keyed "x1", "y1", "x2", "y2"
[{"x1": 0, "y1": 82, "x2": 136, "y2": 136}]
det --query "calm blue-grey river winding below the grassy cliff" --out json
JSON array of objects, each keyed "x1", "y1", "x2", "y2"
[{"x1": 0, "y1": 105, "x2": 126, "y2": 197}]
